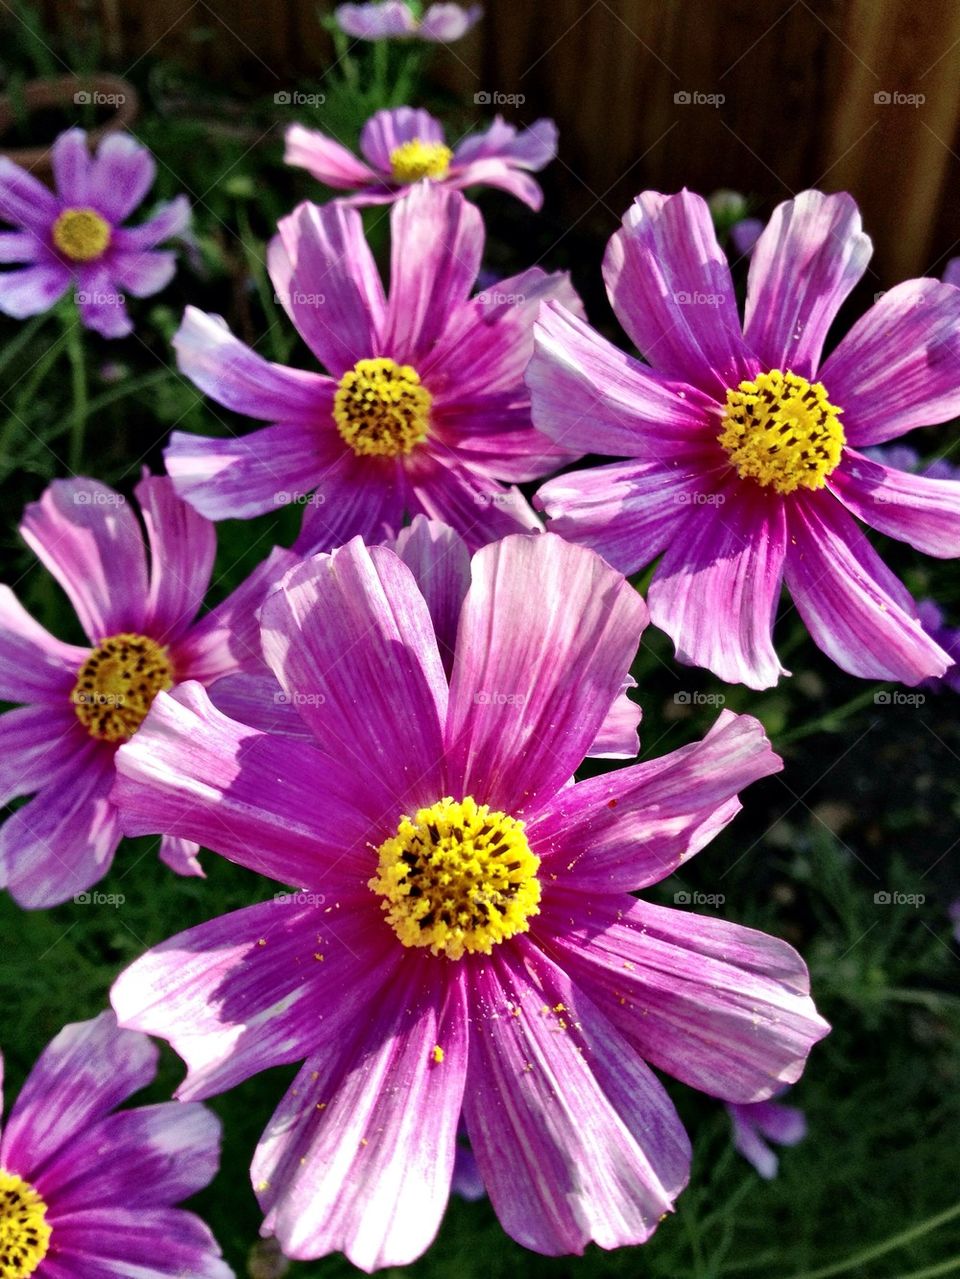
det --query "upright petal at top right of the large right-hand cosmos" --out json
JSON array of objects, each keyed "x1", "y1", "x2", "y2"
[{"x1": 744, "y1": 191, "x2": 873, "y2": 376}]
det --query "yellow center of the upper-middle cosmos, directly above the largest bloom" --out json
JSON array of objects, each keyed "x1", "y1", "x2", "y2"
[{"x1": 334, "y1": 359, "x2": 431, "y2": 458}]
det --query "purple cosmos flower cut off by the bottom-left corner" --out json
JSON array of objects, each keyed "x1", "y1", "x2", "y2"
[{"x1": 0, "y1": 1013, "x2": 233, "y2": 1279}]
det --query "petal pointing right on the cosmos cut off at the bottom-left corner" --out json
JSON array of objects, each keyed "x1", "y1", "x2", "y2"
[{"x1": 41, "y1": 1101, "x2": 220, "y2": 1216}]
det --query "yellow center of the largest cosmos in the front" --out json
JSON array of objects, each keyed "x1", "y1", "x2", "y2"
[{"x1": 368, "y1": 796, "x2": 539, "y2": 959}]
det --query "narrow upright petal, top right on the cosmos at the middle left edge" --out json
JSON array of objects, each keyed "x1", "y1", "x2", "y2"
[{"x1": 134, "y1": 476, "x2": 216, "y2": 643}]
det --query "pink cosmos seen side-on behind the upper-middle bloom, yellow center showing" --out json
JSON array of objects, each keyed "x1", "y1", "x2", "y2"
[{"x1": 284, "y1": 106, "x2": 557, "y2": 208}]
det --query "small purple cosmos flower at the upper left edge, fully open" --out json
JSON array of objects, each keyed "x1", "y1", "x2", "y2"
[{"x1": 0, "y1": 129, "x2": 190, "y2": 338}]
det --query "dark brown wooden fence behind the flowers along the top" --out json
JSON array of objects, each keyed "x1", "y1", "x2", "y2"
[{"x1": 11, "y1": 0, "x2": 960, "y2": 286}]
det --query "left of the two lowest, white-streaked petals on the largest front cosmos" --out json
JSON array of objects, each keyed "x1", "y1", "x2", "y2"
[{"x1": 251, "y1": 955, "x2": 468, "y2": 1271}]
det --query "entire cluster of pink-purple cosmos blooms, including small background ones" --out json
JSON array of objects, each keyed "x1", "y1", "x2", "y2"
[{"x1": 0, "y1": 3, "x2": 960, "y2": 1279}]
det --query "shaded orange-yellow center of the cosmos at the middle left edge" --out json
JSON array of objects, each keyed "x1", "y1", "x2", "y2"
[{"x1": 73, "y1": 634, "x2": 174, "y2": 746}]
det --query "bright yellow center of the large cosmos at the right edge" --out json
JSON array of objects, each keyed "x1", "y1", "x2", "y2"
[{"x1": 717, "y1": 368, "x2": 846, "y2": 492}]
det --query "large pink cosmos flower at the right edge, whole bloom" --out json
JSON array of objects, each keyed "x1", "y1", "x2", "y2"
[{"x1": 527, "y1": 191, "x2": 960, "y2": 688}]
